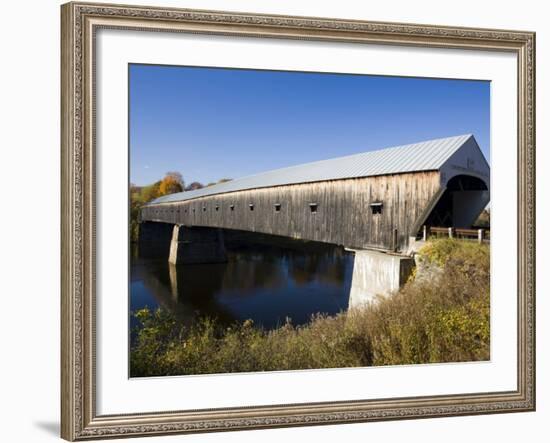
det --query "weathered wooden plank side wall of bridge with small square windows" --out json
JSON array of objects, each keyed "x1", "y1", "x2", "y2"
[{"x1": 141, "y1": 171, "x2": 440, "y2": 250}]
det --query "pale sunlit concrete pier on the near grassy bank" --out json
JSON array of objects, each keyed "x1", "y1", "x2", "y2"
[{"x1": 349, "y1": 250, "x2": 415, "y2": 309}]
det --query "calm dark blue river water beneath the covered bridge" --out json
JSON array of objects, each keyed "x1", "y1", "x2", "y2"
[{"x1": 130, "y1": 239, "x2": 353, "y2": 329}]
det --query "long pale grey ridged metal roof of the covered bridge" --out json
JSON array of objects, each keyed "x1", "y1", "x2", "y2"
[{"x1": 149, "y1": 134, "x2": 473, "y2": 204}]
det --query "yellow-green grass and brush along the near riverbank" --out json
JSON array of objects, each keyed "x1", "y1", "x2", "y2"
[{"x1": 130, "y1": 239, "x2": 490, "y2": 377}]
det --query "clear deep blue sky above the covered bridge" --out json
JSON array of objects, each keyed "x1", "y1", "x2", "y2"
[{"x1": 129, "y1": 65, "x2": 490, "y2": 185}]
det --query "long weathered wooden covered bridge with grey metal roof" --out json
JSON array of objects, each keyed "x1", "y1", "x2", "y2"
[{"x1": 140, "y1": 135, "x2": 490, "y2": 263}]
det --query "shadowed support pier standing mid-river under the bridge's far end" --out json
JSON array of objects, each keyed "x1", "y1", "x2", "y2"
[{"x1": 168, "y1": 225, "x2": 227, "y2": 264}]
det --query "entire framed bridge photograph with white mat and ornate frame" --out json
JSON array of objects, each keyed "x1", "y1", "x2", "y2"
[{"x1": 61, "y1": 2, "x2": 535, "y2": 441}]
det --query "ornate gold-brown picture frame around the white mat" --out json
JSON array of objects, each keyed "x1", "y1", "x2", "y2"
[{"x1": 61, "y1": 3, "x2": 535, "y2": 440}]
